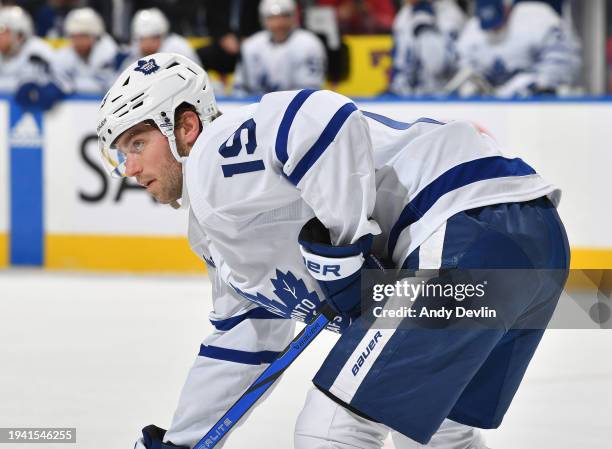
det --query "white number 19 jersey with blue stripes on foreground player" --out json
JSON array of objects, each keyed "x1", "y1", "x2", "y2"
[{"x1": 161, "y1": 89, "x2": 559, "y2": 447}]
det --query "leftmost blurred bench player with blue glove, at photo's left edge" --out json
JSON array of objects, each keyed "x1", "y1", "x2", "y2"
[{"x1": 0, "y1": 6, "x2": 70, "y2": 109}]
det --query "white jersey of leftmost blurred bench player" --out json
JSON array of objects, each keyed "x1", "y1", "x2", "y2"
[{"x1": 0, "y1": 36, "x2": 69, "y2": 93}]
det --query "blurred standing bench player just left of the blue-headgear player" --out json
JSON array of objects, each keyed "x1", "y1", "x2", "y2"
[{"x1": 390, "y1": 0, "x2": 466, "y2": 95}]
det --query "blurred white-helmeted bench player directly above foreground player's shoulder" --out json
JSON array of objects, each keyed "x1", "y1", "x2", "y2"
[{"x1": 234, "y1": 0, "x2": 326, "y2": 96}]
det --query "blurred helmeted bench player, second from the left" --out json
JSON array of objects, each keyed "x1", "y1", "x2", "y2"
[{"x1": 57, "y1": 8, "x2": 119, "y2": 94}]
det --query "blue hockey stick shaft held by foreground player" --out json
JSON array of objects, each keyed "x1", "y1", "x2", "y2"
[{"x1": 193, "y1": 304, "x2": 336, "y2": 449}]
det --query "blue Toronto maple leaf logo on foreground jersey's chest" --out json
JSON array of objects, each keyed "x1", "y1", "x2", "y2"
[{"x1": 232, "y1": 269, "x2": 348, "y2": 332}]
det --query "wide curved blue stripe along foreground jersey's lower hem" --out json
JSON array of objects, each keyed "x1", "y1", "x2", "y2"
[{"x1": 387, "y1": 156, "x2": 535, "y2": 257}]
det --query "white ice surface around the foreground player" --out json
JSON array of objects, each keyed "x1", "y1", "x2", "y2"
[{"x1": 0, "y1": 270, "x2": 612, "y2": 449}]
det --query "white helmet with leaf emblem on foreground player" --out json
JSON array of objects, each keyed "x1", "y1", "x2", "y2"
[{"x1": 97, "y1": 53, "x2": 219, "y2": 177}]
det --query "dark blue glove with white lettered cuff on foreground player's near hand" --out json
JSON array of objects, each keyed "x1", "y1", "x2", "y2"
[{"x1": 298, "y1": 218, "x2": 384, "y2": 318}]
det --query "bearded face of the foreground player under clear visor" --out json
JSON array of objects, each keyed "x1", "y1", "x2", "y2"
[{"x1": 115, "y1": 123, "x2": 183, "y2": 204}]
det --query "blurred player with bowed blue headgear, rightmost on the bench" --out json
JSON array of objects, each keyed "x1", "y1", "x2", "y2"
[{"x1": 445, "y1": 0, "x2": 582, "y2": 98}]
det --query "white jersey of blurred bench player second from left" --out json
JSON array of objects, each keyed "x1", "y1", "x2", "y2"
[{"x1": 57, "y1": 34, "x2": 119, "y2": 94}]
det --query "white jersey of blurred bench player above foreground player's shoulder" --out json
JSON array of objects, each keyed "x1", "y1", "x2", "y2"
[{"x1": 233, "y1": 29, "x2": 327, "y2": 96}]
